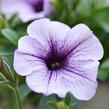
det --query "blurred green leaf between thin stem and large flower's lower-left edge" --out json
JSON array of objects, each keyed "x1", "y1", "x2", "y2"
[{"x1": 19, "y1": 84, "x2": 31, "y2": 100}]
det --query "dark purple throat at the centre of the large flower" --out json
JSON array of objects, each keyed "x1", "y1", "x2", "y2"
[{"x1": 45, "y1": 40, "x2": 66, "y2": 70}]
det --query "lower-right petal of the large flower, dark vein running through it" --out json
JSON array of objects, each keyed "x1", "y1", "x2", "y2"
[{"x1": 61, "y1": 61, "x2": 99, "y2": 100}]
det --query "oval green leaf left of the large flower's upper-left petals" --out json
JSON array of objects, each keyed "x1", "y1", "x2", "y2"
[{"x1": 1, "y1": 28, "x2": 19, "y2": 45}]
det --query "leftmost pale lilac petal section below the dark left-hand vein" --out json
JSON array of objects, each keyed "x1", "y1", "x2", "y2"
[{"x1": 14, "y1": 50, "x2": 46, "y2": 76}]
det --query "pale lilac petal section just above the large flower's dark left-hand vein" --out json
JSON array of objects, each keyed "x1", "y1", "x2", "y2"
[{"x1": 18, "y1": 36, "x2": 49, "y2": 57}]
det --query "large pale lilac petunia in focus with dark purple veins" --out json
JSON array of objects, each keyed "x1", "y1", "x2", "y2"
[{"x1": 14, "y1": 18, "x2": 103, "y2": 100}]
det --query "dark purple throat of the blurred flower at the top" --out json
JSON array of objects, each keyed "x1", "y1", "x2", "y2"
[{"x1": 31, "y1": 0, "x2": 44, "y2": 12}]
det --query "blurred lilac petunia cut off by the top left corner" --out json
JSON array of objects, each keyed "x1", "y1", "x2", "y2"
[{"x1": 0, "y1": 0, "x2": 52, "y2": 22}]
